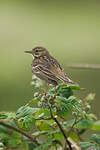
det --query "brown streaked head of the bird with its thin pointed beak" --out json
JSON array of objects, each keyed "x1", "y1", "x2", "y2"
[{"x1": 25, "y1": 46, "x2": 49, "y2": 58}]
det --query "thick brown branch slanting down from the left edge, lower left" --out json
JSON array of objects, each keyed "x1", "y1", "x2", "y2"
[{"x1": 0, "y1": 120, "x2": 40, "y2": 146}]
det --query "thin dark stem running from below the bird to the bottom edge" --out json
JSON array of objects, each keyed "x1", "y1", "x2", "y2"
[{"x1": 49, "y1": 107, "x2": 73, "y2": 150}]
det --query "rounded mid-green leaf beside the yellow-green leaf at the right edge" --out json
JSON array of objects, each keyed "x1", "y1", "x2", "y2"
[{"x1": 76, "y1": 119, "x2": 93, "y2": 129}]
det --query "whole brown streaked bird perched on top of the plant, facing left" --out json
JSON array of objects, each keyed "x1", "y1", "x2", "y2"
[{"x1": 25, "y1": 46, "x2": 75, "y2": 86}]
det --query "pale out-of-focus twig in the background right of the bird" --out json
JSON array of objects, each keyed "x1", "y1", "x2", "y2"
[{"x1": 68, "y1": 64, "x2": 100, "y2": 70}]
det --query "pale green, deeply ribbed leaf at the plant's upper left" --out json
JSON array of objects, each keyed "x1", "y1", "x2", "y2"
[{"x1": 16, "y1": 106, "x2": 40, "y2": 118}]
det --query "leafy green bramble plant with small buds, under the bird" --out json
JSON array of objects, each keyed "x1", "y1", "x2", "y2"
[{"x1": 0, "y1": 78, "x2": 100, "y2": 150}]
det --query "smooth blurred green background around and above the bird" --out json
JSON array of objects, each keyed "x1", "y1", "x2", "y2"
[{"x1": 0, "y1": 0, "x2": 100, "y2": 118}]
